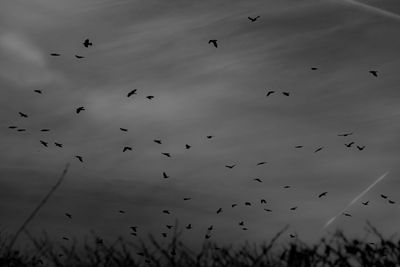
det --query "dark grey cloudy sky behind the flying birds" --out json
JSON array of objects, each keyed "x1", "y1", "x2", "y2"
[{"x1": 0, "y1": 0, "x2": 400, "y2": 250}]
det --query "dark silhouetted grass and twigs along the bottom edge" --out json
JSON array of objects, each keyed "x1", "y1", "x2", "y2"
[{"x1": 0, "y1": 223, "x2": 400, "y2": 267}]
